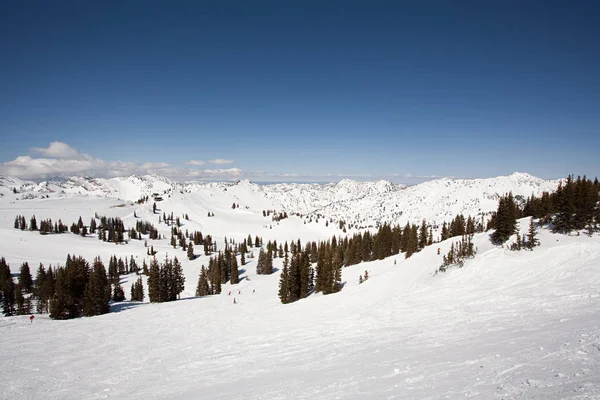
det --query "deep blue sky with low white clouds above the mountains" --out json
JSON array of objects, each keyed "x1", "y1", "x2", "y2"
[{"x1": 0, "y1": 0, "x2": 600, "y2": 182}]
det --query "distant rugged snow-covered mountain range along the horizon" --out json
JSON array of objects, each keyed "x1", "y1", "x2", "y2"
[{"x1": 0, "y1": 173, "x2": 559, "y2": 228}]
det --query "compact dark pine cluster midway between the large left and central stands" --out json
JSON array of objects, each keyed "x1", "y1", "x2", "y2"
[{"x1": 148, "y1": 256, "x2": 185, "y2": 303}]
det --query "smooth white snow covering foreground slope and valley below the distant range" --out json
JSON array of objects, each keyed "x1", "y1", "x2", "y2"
[{"x1": 0, "y1": 173, "x2": 600, "y2": 399}]
